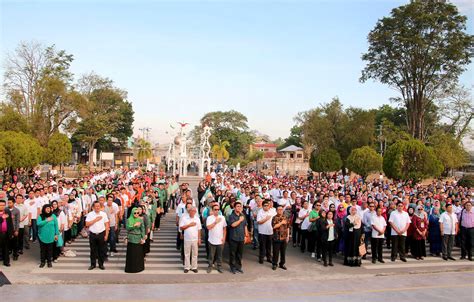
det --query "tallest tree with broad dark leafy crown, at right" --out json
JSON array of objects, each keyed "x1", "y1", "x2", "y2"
[{"x1": 361, "y1": 0, "x2": 474, "y2": 140}]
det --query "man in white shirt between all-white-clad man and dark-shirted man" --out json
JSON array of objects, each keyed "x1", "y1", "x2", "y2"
[{"x1": 206, "y1": 203, "x2": 227, "y2": 273}]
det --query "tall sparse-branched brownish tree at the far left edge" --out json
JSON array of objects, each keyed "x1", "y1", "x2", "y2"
[{"x1": 3, "y1": 42, "x2": 82, "y2": 146}]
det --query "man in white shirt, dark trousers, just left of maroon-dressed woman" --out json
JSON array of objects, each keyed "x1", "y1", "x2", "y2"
[{"x1": 388, "y1": 201, "x2": 411, "y2": 262}]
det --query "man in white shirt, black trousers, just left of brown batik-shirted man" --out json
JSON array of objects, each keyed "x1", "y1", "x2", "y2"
[{"x1": 257, "y1": 200, "x2": 276, "y2": 264}]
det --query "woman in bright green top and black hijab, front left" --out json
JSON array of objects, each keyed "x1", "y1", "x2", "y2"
[{"x1": 36, "y1": 204, "x2": 59, "y2": 267}]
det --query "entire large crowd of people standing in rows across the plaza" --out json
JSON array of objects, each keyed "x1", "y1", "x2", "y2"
[{"x1": 0, "y1": 169, "x2": 474, "y2": 274}]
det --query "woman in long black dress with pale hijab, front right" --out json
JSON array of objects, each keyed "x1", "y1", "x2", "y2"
[{"x1": 344, "y1": 207, "x2": 362, "y2": 266}]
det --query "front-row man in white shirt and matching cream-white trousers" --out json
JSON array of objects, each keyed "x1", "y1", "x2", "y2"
[{"x1": 179, "y1": 206, "x2": 202, "y2": 273}]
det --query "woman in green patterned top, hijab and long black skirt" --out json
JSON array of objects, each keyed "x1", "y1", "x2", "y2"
[{"x1": 125, "y1": 208, "x2": 146, "y2": 273}]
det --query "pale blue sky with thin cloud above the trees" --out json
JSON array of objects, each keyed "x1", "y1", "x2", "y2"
[{"x1": 0, "y1": 0, "x2": 473, "y2": 143}]
